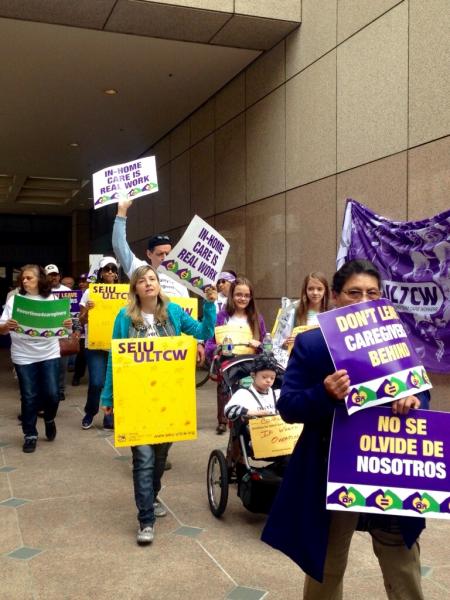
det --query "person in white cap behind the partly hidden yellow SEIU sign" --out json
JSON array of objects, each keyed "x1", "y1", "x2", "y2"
[{"x1": 75, "y1": 256, "x2": 119, "y2": 430}]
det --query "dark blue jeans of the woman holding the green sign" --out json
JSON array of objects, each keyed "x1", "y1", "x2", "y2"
[{"x1": 14, "y1": 358, "x2": 60, "y2": 437}]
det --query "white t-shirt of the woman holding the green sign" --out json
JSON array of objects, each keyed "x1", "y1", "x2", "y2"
[{"x1": 0, "y1": 294, "x2": 61, "y2": 365}]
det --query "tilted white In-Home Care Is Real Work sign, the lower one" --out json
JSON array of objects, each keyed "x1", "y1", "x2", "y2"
[{"x1": 159, "y1": 215, "x2": 230, "y2": 298}]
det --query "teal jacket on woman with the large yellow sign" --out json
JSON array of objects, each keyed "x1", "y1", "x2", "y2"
[{"x1": 100, "y1": 302, "x2": 216, "y2": 406}]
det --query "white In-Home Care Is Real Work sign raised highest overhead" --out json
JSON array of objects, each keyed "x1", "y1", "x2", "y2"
[{"x1": 92, "y1": 156, "x2": 158, "y2": 208}]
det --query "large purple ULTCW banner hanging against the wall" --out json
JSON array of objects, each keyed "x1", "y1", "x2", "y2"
[{"x1": 337, "y1": 200, "x2": 450, "y2": 373}]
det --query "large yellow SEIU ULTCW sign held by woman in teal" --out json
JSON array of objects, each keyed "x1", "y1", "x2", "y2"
[{"x1": 111, "y1": 336, "x2": 197, "y2": 446}]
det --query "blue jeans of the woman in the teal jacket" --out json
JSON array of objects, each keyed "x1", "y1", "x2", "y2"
[{"x1": 131, "y1": 444, "x2": 171, "y2": 528}]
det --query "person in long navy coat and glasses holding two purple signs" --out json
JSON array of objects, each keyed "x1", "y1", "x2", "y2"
[{"x1": 262, "y1": 260, "x2": 429, "y2": 600}]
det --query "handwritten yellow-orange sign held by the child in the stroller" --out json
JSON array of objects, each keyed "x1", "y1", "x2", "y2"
[{"x1": 248, "y1": 415, "x2": 303, "y2": 458}]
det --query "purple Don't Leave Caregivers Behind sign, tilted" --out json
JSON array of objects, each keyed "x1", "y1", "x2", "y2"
[{"x1": 318, "y1": 298, "x2": 432, "y2": 414}]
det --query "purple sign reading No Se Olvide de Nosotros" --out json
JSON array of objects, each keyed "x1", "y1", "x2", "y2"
[{"x1": 327, "y1": 407, "x2": 450, "y2": 519}]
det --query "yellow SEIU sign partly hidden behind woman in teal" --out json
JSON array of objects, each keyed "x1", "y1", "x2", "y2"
[{"x1": 88, "y1": 283, "x2": 130, "y2": 350}]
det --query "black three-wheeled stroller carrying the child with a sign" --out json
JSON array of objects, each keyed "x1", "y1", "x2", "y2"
[{"x1": 206, "y1": 353, "x2": 287, "y2": 517}]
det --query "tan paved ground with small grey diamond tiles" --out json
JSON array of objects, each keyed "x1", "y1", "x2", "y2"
[{"x1": 0, "y1": 350, "x2": 450, "y2": 600}]
